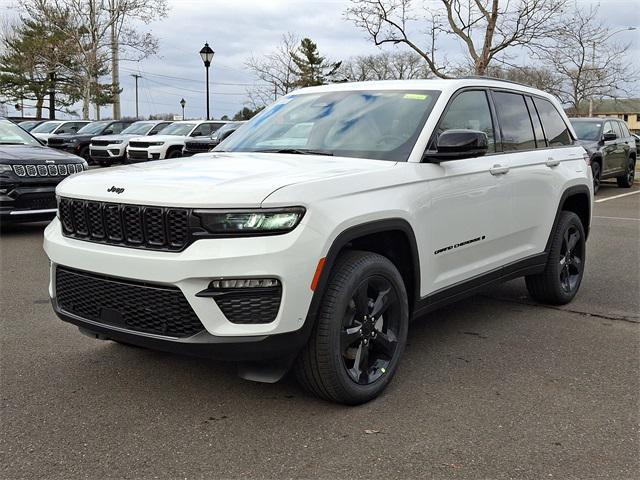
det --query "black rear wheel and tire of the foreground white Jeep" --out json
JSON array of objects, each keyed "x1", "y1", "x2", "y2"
[{"x1": 525, "y1": 211, "x2": 586, "y2": 305}]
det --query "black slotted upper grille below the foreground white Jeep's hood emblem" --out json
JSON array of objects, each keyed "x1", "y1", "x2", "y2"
[{"x1": 59, "y1": 198, "x2": 191, "y2": 251}]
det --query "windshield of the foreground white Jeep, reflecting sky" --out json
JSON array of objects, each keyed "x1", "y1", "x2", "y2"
[{"x1": 216, "y1": 90, "x2": 438, "y2": 161}]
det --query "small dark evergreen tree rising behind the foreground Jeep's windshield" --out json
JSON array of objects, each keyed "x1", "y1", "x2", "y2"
[{"x1": 291, "y1": 38, "x2": 342, "y2": 88}]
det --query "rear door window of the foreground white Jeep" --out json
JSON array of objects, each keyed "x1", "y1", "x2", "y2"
[{"x1": 493, "y1": 92, "x2": 536, "y2": 152}]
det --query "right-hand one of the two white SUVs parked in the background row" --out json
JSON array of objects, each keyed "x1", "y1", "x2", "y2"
[{"x1": 127, "y1": 120, "x2": 220, "y2": 163}]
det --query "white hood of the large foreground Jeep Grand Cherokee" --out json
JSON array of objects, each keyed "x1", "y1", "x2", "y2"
[{"x1": 56, "y1": 152, "x2": 395, "y2": 208}]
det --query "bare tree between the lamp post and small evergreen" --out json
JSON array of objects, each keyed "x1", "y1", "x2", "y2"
[{"x1": 245, "y1": 33, "x2": 300, "y2": 109}]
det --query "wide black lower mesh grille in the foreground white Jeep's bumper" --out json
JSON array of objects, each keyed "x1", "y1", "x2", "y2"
[{"x1": 56, "y1": 267, "x2": 204, "y2": 337}]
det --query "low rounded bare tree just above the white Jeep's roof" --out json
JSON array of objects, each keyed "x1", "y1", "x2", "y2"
[{"x1": 336, "y1": 51, "x2": 432, "y2": 82}]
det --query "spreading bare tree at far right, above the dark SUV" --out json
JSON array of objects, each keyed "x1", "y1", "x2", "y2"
[{"x1": 538, "y1": 6, "x2": 638, "y2": 115}]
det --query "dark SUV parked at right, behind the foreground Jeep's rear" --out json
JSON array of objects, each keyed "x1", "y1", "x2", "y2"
[{"x1": 571, "y1": 118, "x2": 638, "y2": 193}]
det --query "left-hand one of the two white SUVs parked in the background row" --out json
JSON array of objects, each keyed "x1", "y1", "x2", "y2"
[{"x1": 89, "y1": 120, "x2": 172, "y2": 167}]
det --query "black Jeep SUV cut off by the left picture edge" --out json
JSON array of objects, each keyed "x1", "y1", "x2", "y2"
[{"x1": 0, "y1": 119, "x2": 87, "y2": 223}]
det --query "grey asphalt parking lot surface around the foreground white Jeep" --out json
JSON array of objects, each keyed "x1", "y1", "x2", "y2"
[{"x1": 0, "y1": 184, "x2": 640, "y2": 479}]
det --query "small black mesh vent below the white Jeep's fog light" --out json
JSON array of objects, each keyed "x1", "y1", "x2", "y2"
[{"x1": 214, "y1": 287, "x2": 282, "y2": 324}]
